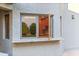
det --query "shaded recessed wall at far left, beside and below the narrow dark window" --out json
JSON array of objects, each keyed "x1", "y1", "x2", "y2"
[{"x1": 0, "y1": 10, "x2": 12, "y2": 55}]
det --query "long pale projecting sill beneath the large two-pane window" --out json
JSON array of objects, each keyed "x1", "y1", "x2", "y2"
[{"x1": 12, "y1": 38, "x2": 63, "y2": 43}]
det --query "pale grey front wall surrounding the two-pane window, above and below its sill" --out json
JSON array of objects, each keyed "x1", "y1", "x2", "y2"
[{"x1": 12, "y1": 4, "x2": 65, "y2": 55}]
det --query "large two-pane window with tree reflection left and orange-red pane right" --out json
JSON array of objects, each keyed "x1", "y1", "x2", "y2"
[{"x1": 21, "y1": 14, "x2": 52, "y2": 38}]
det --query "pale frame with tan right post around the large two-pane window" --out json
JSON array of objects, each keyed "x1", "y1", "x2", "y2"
[{"x1": 20, "y1": 13, "x2": 54, "y2": 39}]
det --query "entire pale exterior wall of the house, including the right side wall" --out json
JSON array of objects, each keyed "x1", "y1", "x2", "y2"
[{"x1": 0, "y1": 4, "x2": 79, "y2": 55}]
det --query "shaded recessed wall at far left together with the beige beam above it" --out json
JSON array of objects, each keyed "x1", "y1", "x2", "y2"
[{"x1": 0, "y1": 3, "x2": 12, "y2": 55}]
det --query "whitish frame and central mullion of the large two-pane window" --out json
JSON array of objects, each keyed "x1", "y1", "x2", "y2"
[{"x1": 20, "y1": 13, "x2": 53, "y2": 40}]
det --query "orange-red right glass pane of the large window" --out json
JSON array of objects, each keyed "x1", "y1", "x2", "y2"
[{"x1": 39, "y1": 16, "x2": 49, "y2": 37}]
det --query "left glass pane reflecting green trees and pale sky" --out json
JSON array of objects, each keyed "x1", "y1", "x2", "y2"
[{"x1": 22, "y1": 16, "x2": 36, "y2": 37}]
